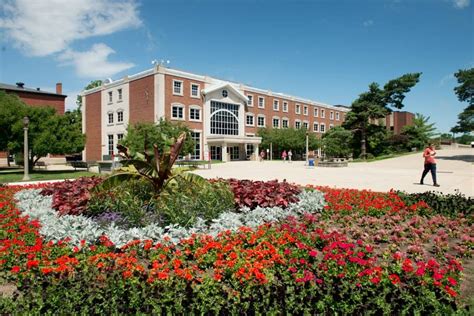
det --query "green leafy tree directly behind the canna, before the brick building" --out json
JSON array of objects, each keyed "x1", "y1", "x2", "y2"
[{"x1": 121, "y1": 119, "x2": 194, "y2": 154}]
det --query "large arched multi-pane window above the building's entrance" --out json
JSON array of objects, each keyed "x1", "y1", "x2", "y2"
[{"x1": 210, "y1": 101, "x2": 239, "y2": 135}]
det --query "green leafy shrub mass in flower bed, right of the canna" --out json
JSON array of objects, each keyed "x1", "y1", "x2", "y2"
[{"x1": 155, "y1": 177, "x2": 234, "y2": 227}]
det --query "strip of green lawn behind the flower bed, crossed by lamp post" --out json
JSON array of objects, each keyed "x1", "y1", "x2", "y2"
[{"x1": 0, "y1": 168, "x2": 97, "y2": 183}]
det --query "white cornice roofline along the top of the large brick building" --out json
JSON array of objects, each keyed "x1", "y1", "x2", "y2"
[{"x1": 81, "y1": 65, "x2": 350, "y2": 112}]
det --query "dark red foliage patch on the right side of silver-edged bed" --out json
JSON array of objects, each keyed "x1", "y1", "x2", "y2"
[{"x1": 221, "y1": 179, "x2": 301, "y2": 209}]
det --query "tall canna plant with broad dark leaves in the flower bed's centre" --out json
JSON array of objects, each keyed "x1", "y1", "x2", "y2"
[{"x1": 96, "y1": 132, "x2": 208, "y2": 196}]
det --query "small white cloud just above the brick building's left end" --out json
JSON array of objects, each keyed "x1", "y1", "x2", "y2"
[{"x1": 59, "y1": 43, "x2": 134, "y2": 78}]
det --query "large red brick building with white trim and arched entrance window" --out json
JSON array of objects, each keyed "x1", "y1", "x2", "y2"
[{"x1": 82, "y1": 65, "x2": 349, "y2": 161}]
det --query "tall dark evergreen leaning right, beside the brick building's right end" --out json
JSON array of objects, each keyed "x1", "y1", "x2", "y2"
[{"x1": 344, "y1": 73, "x2": 421, "y2": 159}]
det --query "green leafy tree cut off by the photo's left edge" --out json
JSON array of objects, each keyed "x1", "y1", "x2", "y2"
[{"x1": 0, "y1": 91, "x2": 27, "y2": 166}]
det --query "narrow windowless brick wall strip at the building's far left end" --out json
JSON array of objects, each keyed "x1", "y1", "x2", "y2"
[{"x1": 84, "y1": 91, "x2": 102, "y2": 161}]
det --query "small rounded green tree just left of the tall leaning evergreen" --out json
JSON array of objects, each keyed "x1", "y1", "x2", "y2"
[{"x1": 322, "y1": 126, "x2": 352, "y2": 158}]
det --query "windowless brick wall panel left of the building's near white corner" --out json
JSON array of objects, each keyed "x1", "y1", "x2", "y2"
[{"x1": 129, "y1": 76, "x2": 155, "y2": 124}]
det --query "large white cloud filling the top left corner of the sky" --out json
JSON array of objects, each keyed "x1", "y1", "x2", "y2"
[{"x1": 0, "y1": 0, "x2": 142, "y2": 56}]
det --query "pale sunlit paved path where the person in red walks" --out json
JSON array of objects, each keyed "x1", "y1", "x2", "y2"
[{"x1": 196, "y1": 148, "x2": 474, "y2": 196}]
